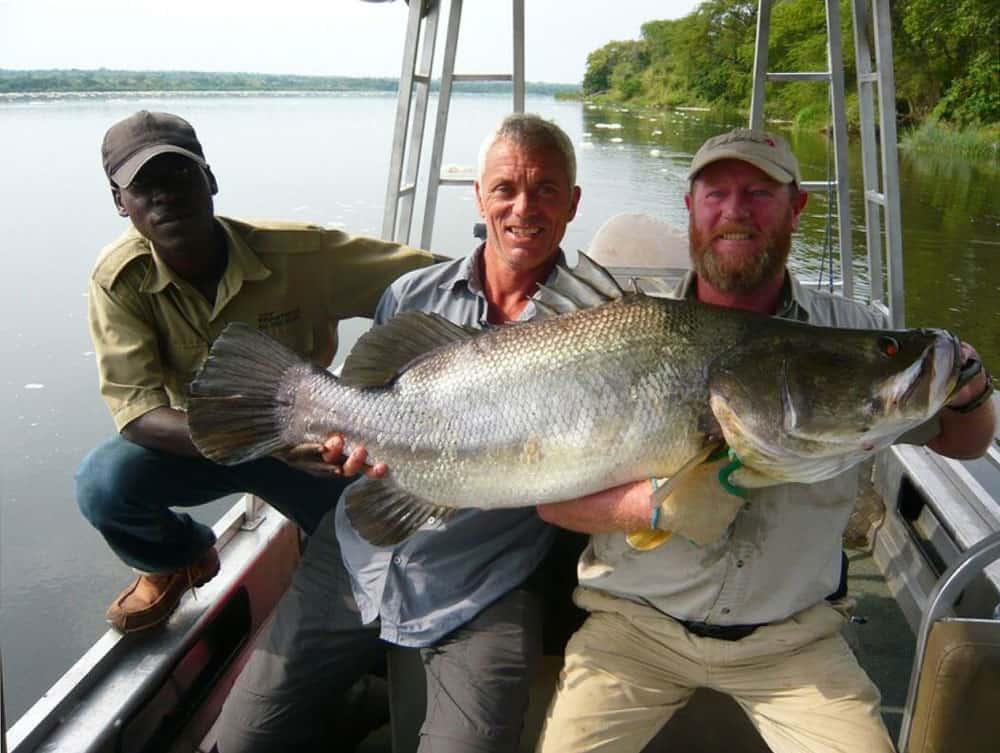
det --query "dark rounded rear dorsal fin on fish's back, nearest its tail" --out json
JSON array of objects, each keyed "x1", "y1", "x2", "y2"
[{"x1": 340, "y1": 311, "x2": 482, "y2": 387}]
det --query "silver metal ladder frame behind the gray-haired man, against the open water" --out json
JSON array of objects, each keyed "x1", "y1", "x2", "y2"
[{"x1": 382, "y1": 0, "x2": 524, "y2": 253}]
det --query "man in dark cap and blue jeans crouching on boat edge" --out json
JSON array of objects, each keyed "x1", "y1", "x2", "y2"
[{"x1": 76, "y1": 111, "x2": 433, "y2": 632}]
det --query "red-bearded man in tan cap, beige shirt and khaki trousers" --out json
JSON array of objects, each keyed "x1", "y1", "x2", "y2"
[{"x1": 537, "y1": 128, "x2": 995, "y2": 753}]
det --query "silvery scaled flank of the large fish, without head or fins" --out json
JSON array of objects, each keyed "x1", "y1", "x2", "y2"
[{"x1": 328, "y1": 296, "x2": 728, "y2": 508}]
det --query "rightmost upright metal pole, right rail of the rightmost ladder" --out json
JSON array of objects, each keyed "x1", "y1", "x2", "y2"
[{"x1": 874, "y1": 0, "x2": 906, "y2": 328}]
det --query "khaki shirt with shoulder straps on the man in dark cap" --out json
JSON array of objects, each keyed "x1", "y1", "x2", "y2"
[{"x1": 89, "y1": 217, "x2": 433, "y2": 431}]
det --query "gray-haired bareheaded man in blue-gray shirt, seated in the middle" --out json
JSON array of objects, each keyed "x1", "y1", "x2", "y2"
[{"x1": 219, "y1": 115, "x2": 583, "y2": 753}]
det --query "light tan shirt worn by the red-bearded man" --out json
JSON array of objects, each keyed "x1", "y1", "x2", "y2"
[{"x1": 579, "y1": 274, "x2": 928, "y2": 625}]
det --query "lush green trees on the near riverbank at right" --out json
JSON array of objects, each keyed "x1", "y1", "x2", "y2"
[{"x1": 583, "y1": 0, "x2": 1000, "y2": 127}]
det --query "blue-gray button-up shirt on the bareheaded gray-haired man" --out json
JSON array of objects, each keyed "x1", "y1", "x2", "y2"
[{"x1": 336, "y1": 246, "x2": 564, "y2": 646}]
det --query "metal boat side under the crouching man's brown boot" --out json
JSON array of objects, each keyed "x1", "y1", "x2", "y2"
[{"x1": 7, "y1": 495, "x2": 299, "y2": 753}]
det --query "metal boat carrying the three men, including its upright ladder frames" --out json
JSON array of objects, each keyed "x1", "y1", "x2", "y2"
[{"x1": 5, "y1": 0, "x2": 1000, "y2": 753}]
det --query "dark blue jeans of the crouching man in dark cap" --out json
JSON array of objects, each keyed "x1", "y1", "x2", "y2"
[{"x1": 76, "y1": 435, "x2": 347, "y2": 572}]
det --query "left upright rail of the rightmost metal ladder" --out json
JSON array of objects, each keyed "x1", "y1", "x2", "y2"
[{"x1": 851, "y1": 0, "x2": 886, "y2": 305}]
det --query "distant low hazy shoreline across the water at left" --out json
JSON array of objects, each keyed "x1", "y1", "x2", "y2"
[{"x1": 0, "y1": 68, "x2": 580, "y2": 96}]
